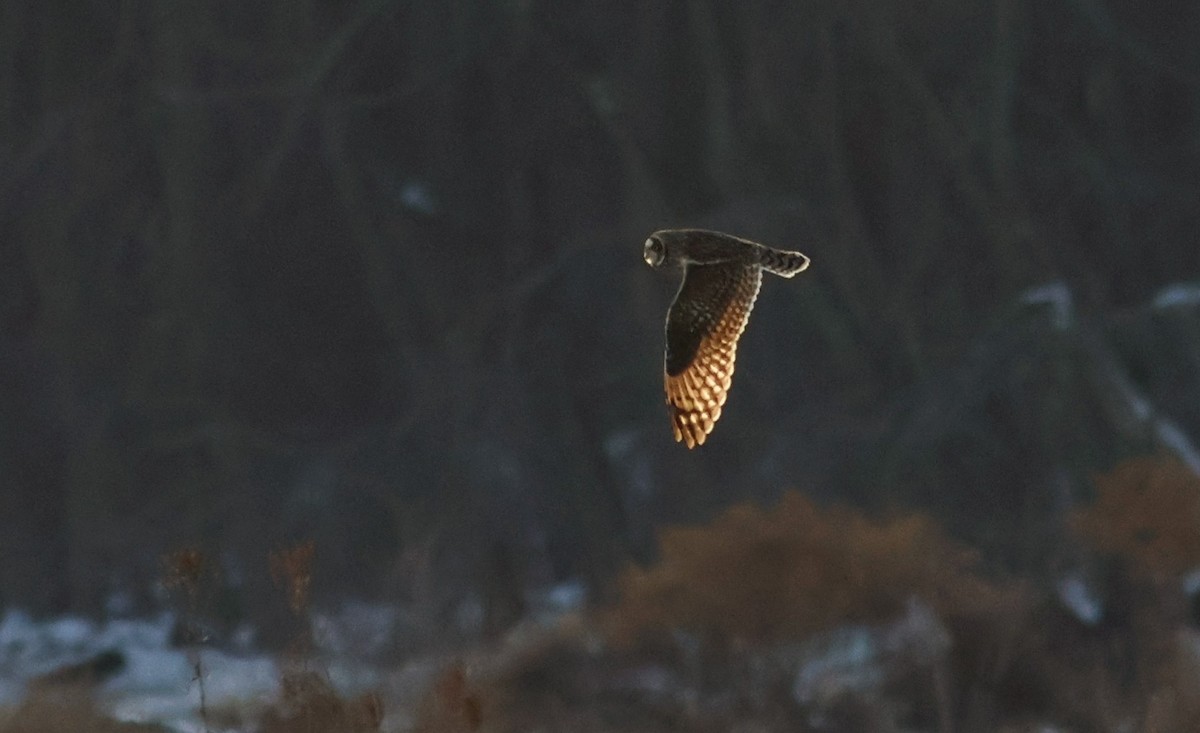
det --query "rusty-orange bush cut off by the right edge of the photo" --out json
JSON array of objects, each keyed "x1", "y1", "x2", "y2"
[{"x1": 1072, "y1": 457, "x2": 1200, "y2": 579}]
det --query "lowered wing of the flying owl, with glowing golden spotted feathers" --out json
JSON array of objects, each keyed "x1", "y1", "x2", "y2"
[{"x1": 665, "y1": 263, "x2": 762, "y2": 447}]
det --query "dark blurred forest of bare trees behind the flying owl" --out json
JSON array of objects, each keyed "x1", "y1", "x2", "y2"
[{"x1": 0, "y1": 0, "x2": 1200, "y2": 643}]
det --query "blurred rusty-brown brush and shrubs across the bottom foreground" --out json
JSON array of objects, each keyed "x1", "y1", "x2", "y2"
[{"x1": 0, "y1": 457, "x2": 1200, "y2": 733}]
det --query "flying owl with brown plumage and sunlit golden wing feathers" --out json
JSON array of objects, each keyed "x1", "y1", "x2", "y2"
[{"x1": 642, "y1": 229, "x2": 809, "y2": 447}]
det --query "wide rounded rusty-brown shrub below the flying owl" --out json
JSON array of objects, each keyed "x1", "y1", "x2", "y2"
[{"x1": 607, "y1": 492, "x2": 1000, "y2": 641}]
